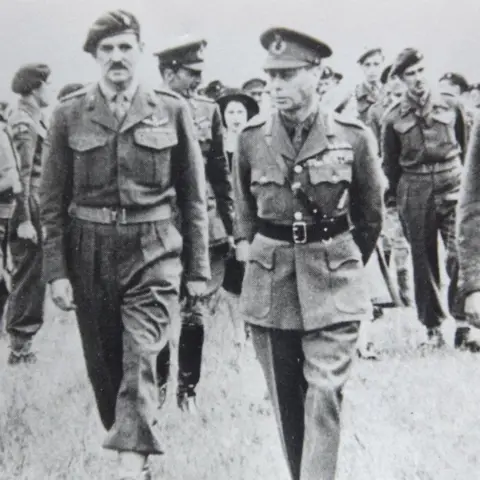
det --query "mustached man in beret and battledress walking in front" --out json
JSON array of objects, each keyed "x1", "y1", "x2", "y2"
[{"x1": 41, "y1": 10, "x2": 209, "y2": 480}]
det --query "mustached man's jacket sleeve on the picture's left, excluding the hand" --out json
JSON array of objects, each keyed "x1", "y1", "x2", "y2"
[{"x1": 40, "y1": 107, "x2": 73, "y2": 282}]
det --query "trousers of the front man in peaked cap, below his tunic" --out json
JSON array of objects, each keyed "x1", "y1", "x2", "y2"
[{"x1": 250, "y1": 322, "x2": 359, "y2": 480}]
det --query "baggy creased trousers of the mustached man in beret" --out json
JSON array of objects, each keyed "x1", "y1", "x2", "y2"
[{"x1": 68, "y1": 219, "x2": 182, "y2": 454}]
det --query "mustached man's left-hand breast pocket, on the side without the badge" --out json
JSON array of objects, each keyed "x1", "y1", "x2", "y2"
[{"x1": 68, "y1": 133, "x2": 109, "y2": 188}]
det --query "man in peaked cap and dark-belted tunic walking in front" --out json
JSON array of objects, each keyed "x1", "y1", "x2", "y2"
[{"x1": 233, "y1": 28, "x2": 383, "y2": 480}]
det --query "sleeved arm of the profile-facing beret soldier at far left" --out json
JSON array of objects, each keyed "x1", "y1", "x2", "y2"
[{"x1": 9, "y1": 114, "x2": 37, "y2": 223}]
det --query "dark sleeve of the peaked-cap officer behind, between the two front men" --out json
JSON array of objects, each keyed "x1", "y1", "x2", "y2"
[{"x1": 206, "y1": 105, "x2": 233, "y2": 237}]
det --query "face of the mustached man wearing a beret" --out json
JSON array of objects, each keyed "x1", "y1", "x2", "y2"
[{"x1": 95, "y1": 33, "x2": 143, "y2": 87}]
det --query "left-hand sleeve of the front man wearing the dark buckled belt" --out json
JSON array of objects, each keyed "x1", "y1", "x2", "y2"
[{"x1": 233, "y1": 132, "x2": 257, "y2": 242}]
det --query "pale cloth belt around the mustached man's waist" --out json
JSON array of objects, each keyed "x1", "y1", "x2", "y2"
[{"x1": 68, "y1": 204, "x2": 172, "y2": 225}]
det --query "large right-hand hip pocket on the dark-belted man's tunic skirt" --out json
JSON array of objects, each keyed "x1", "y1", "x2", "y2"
[{"x1": 327, "y1": 235, "x2": 370, "y2": 315}]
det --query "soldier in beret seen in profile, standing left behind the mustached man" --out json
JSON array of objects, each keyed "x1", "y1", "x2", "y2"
[{"x1": 6, "y1": 64, "x2": 51, "y2": 365}]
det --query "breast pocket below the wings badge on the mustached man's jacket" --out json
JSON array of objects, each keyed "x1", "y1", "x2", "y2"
[{"x1": 131, "y1": 129, "x2": 178, "y2": 185}]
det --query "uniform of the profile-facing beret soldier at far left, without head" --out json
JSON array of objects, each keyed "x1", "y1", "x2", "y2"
[{"x1": 6, "y1": 98, "x2": 46, "y2": 352}]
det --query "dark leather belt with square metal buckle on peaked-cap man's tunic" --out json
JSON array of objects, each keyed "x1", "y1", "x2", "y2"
[{"x1": 258, "y1": 215, "x2": 350, "y2": 244}]
